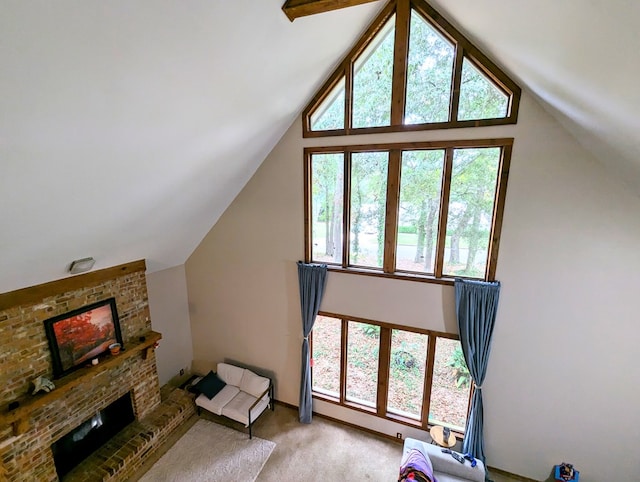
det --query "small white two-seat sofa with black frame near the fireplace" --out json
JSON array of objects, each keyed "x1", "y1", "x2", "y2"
[{"x1": 196, "y1": 363, "x2": 274, "y2": 438}]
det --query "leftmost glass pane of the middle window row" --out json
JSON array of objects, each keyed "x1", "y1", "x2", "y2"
[{"x1": 311, "y1": 154, "x2": 344, "y2": 264}]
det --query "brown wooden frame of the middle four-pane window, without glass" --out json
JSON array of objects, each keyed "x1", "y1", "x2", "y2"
[{"x1": 304, "y1": 138, "x2": 513, "y2": 284}]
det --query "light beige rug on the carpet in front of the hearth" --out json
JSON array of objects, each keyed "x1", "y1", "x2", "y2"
[{"x1": 140, "y1": 419, "x2": 276, "y2": 482}]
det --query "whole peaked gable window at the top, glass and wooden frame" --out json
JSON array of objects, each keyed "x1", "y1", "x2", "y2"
[{"x1": 303, "y1": 0, "x2": 520, "y2": 137}]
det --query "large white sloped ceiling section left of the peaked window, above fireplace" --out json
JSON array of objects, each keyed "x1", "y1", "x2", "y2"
[{"x1": 0, "y1": 0, "x2": 381, "y2": 292}]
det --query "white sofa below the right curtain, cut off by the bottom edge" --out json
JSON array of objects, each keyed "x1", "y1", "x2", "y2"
[{"x1": 402, "y1": 438, "x2": 485, "y2": 482}]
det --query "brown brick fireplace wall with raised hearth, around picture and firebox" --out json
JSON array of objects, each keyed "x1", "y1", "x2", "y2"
[{"x1": 0, "y1": 261, "x2": 186, "y2": 482}]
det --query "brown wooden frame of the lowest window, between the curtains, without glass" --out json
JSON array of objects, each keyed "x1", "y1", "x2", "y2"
[{"x1": 310, "y1": 311, "x2": 473, "y2": 438}]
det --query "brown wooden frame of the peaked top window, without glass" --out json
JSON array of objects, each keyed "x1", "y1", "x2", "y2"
[{"x1": 302, "y1": 0, "x2": 522, "y2": 138}]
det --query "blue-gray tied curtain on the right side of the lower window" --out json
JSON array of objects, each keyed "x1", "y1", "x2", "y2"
[{"x1": 455, "y1": 279, "x2": 500, "y2": 462}]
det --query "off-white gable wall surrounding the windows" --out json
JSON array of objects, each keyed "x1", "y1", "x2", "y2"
[{"x1": 186, "y1": 93, "x2": 640, "y2": 482}]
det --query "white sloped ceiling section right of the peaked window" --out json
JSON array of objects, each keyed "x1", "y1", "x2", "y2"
[{"x1": 430, "y1": 0, "x2": 640, "y2": 195}]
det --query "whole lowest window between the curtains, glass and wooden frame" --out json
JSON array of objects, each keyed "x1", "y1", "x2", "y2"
[{"x1": 311, "y1": 313, "x2": 471, "y2": 434}]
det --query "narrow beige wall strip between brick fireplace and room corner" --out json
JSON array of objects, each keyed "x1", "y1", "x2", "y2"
[{"x1": 147, "y1": 265, "x2": 193, "y2": 385}]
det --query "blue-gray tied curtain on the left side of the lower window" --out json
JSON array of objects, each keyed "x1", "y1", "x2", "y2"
[{"x1": 298, "y1": 261, "x2": 327, "y2": 423}]
